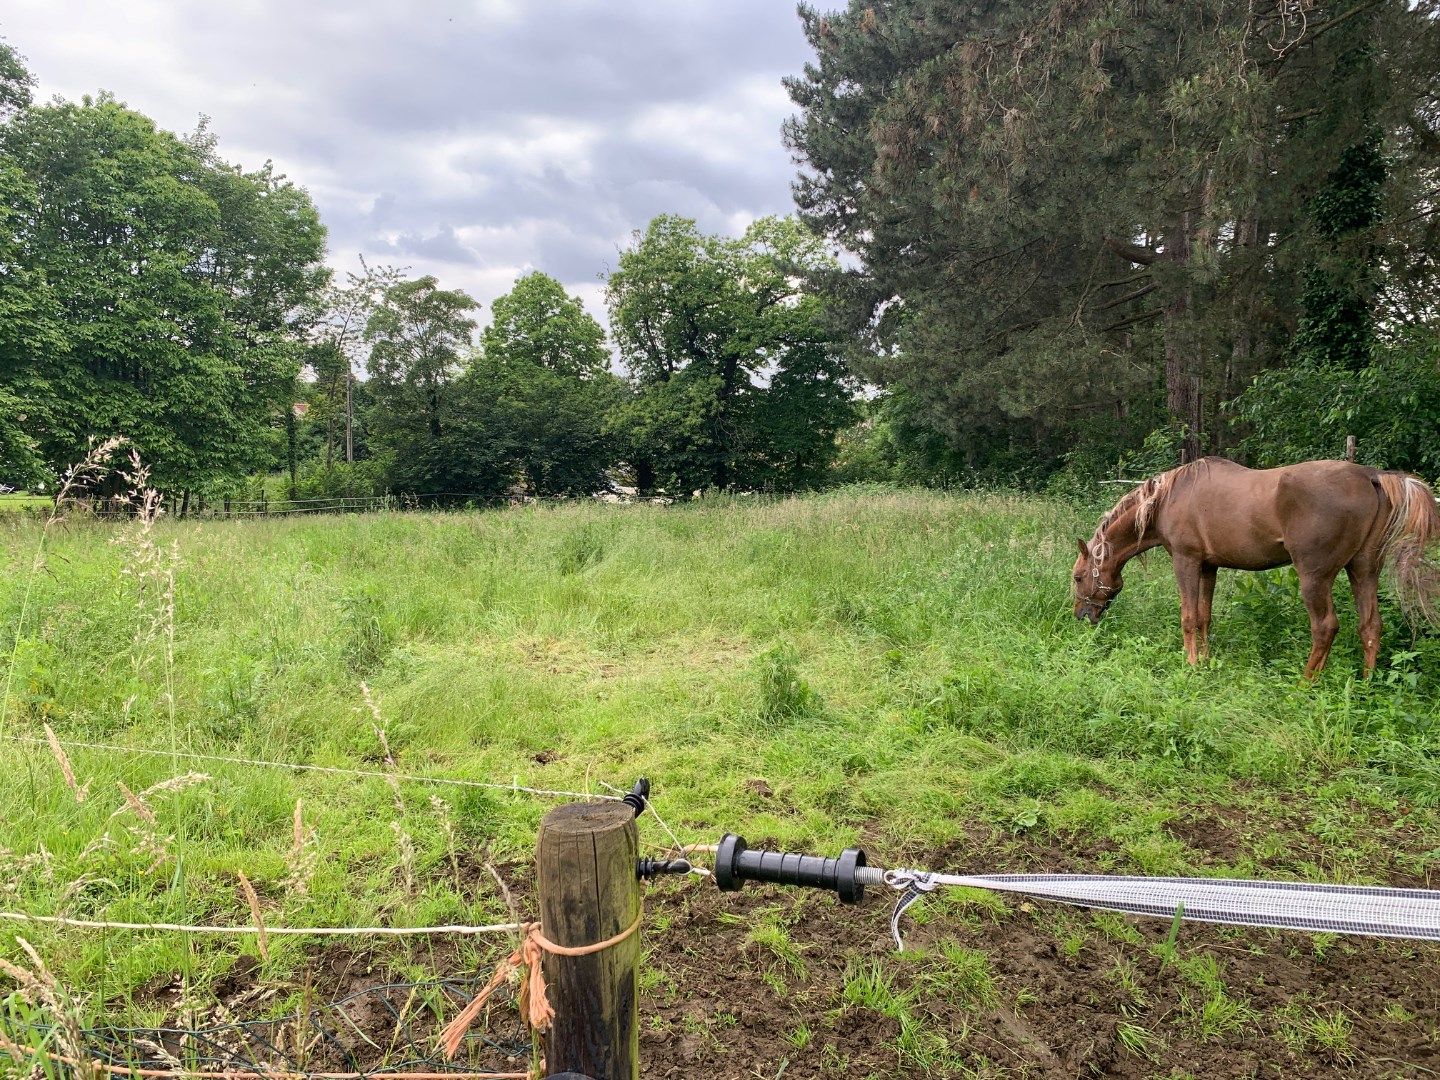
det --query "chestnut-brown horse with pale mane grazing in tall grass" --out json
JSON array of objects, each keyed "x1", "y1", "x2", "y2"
[{"x1": 1074, "y1": 458, "x2": 1440, "y2": 678}]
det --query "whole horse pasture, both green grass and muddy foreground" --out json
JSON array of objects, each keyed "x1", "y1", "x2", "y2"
[{"x1": 0, "y1": 490, "x2": 1440, "y2": 1080}]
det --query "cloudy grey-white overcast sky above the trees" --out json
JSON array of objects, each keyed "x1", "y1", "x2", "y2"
[{"x1": 0, "y1": 0, "x2": 835, "y2": 329}]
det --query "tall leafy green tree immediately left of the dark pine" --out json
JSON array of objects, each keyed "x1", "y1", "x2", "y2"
[{"x1": 608, "y1": 216, "x2": 854, "y2": 494}]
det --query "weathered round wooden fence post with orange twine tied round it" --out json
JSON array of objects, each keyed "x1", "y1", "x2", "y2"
[{"x1": 536, "y1": 802, "x2": 641, "y2": 1080}]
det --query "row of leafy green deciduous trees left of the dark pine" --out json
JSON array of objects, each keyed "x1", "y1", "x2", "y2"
[{"x1": 0, "y1": 46, "x2": 857, "y2": 505}]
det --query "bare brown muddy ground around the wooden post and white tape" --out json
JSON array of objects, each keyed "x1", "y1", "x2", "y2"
[{"x1": 126, "y1": 811, "x2": 1440, "y2": 1080}]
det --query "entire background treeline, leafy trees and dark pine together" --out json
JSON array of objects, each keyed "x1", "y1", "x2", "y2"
[{"x1": 0, "y1": 0, "x2": 1440, "y2": 500}]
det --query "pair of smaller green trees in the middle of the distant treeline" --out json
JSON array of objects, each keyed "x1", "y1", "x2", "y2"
[{"x1": 357, "y1": 274, "x2": 622, "y2": 503}]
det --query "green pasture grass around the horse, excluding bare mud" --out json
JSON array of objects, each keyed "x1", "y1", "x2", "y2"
[{"x1": 0, "y1": 491, "x2": 1440, "y2": 1063}]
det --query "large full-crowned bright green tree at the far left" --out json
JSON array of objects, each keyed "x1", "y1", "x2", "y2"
[{"x1": 0, "y1": 88, "x2": 324, "y2": 490}]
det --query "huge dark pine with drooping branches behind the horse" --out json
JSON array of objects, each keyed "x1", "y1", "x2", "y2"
[{"x1": 786, "y1": 0, "x2": 1440, "y2": 465}]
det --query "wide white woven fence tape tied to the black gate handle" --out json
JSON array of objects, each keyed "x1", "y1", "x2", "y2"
[{"x1": 857, "y1": 868, "x2": 1440, "y2": 940}]
